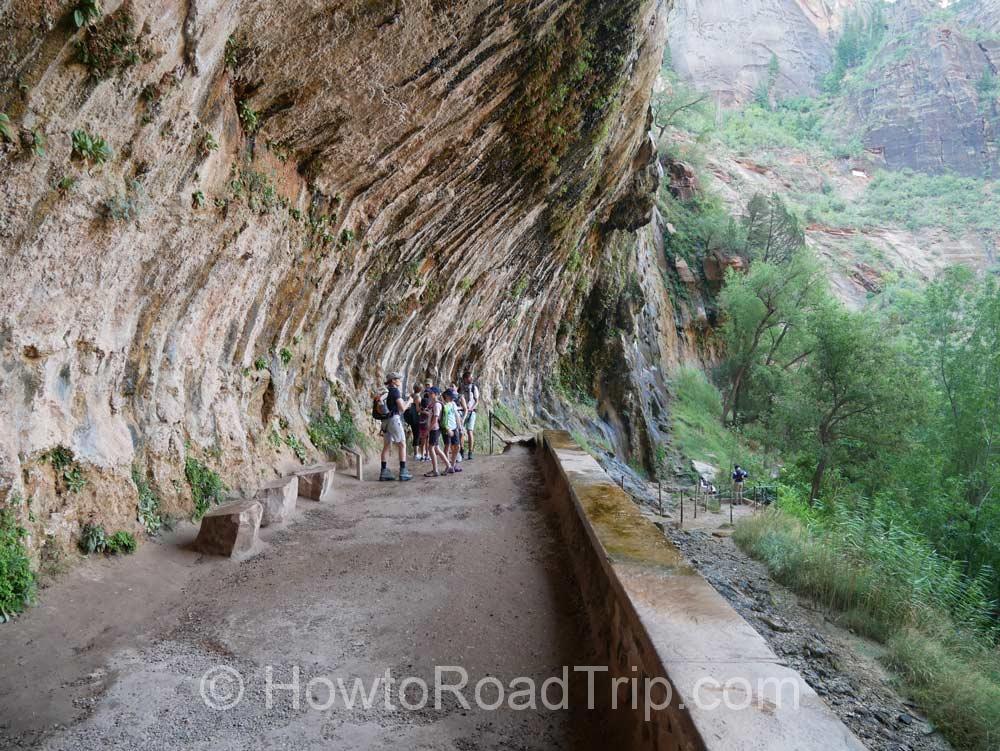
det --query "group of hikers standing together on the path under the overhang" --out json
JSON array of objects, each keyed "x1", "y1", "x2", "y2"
[{"x1": 372, "y1": 370, "x2": 479, "y2": 482}]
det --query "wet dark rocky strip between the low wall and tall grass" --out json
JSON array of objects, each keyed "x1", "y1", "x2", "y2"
[{"x1": 664, "y1": 524, "x2": 951, "y2": 751}]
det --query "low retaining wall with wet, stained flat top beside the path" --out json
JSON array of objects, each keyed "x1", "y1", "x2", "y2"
[{"x1": 538, "y1": 431, "x2": 865, "y2": 751}]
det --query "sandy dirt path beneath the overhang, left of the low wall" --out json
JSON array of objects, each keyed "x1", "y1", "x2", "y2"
[{"x1": 0, "y1": 450, "x2": 611, "y2": 751}]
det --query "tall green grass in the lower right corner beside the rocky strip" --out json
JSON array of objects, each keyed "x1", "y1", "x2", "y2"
[{"x1": 733, "y1": 495, "x2": 1000, "y2": 751}]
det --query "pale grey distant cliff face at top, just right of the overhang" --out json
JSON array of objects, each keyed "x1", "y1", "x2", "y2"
[{"x1": 668, "y1": 0, "x2": 857, "y2": 106}]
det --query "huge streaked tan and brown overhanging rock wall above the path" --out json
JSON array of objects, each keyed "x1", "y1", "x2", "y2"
[{"x1": 0, "y1": 0, "x2": 671, "y2": 552}]
